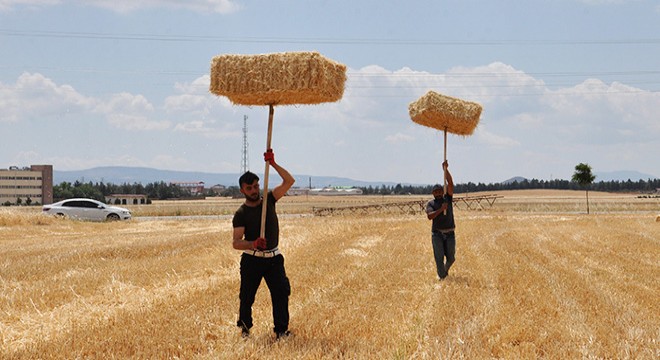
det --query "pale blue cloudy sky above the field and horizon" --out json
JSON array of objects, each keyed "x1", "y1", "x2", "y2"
[{"x1": 0, "y1": 0, "x2": 660, "y2": 184}]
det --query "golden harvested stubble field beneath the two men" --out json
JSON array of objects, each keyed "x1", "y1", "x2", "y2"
[{"x1": 0, "y1": 191, "x2": 660, "y2": 359}]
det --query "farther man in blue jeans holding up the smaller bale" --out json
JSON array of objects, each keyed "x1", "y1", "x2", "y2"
[{"x1": 426, "y1": 160, "x2": 456, "y2": 280}]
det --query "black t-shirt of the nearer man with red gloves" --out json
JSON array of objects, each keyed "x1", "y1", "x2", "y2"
[{"x1": 232, "y1": 191, "x2": 280, "y2": 249}]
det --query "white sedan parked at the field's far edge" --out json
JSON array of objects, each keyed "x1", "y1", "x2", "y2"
[{"x1": 42, "y1": 199, "x2": 131, "y2": 221}]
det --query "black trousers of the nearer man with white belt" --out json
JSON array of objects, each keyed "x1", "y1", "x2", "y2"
[{"x1": 237, "y1": 254, "x2": 291, "y2": 333}]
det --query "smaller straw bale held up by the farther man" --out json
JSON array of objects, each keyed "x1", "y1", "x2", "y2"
[{"x1": 408, "y1": 91, "x2": 481, "y2": 135}]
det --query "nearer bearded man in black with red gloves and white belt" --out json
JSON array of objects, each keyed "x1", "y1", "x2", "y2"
[{"x1": 232, "y1": 149, "x2": 295, "y2": 339}]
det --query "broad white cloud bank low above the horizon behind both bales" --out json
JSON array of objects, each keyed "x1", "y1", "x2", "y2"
[{"x1": 6, "y1": 63, "x2": 660, "y2": 183}]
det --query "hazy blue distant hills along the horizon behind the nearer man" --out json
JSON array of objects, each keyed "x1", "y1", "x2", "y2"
[{"x1": 53, "y1": 166, "x2": 405, "y2": 187}]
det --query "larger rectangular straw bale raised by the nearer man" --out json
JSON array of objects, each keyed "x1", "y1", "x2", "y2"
[{"x1": 209, "y1": 52, "x2": 346, "y2": 105}]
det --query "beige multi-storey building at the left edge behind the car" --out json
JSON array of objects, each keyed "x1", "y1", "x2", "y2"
[{"x1": 0, "y1": 165, "x2": 53, "y2": 205}]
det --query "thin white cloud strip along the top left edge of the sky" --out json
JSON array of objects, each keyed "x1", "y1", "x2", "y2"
[{"x1": 0, "y1": 0, "x2": 241, "y2": 14}]
